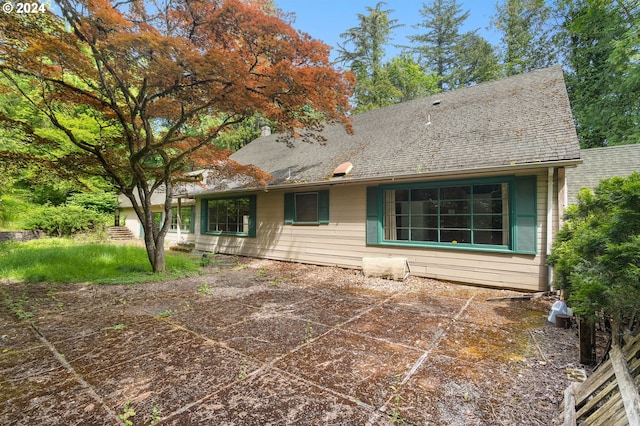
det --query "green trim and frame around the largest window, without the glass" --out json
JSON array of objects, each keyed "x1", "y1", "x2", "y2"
[{"x1": 367, "y1": 175, "x2": 538, "y2": 254}]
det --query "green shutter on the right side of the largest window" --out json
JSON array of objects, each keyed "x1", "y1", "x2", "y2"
[{"x1": 513, "y1": 176, "x2": 538, "y2": 254}]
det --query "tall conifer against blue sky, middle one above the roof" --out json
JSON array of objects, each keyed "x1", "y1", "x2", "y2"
[{"x1": 408, "y1": 0, "x2": 469, "y2": 90}]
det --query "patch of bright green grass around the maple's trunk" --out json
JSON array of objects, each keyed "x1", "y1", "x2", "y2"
[{"x1": 0, "y1": 238, "x2": 200, "y2": 284}]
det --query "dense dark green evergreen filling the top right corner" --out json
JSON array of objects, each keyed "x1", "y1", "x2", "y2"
[{"x1": 558, "y1": 0, "x2": 640, "y2": 148}]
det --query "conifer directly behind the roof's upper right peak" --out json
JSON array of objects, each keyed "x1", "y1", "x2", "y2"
[{"x1": 492, "y1": 0, "x2": 557, "y2": 76}]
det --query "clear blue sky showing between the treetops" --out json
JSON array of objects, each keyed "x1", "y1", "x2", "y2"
[{"x1": 275, "y1": 0, "x2": 500, "y2": 59}]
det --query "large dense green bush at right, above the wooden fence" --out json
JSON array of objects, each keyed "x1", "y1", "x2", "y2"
[{"x1": 548, "y1": 173, "x2": 640, "y2": 325}]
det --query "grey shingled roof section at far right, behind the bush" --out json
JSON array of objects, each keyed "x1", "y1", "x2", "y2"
[{"x1": 567, "y1": 144, "x2": 640, "y2": 204}]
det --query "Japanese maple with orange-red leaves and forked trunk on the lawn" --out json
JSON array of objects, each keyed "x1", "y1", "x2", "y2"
[{"x1": 0, "y1": 0, "x2": 352, "y2": 271}]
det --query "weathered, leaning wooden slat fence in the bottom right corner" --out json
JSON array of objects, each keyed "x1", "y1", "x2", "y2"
[{"x1": 562, "y1": 333, "x2": 640, "y2": 426}]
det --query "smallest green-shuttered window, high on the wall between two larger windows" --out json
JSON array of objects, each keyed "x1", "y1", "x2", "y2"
[{"x1": 284, "y1": 190, "x2": 329, "y2": 225}]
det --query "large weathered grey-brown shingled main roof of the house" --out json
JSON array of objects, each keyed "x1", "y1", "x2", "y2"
[{"x1": 216, "y1": 66, "x2": 580, "y2": 190}]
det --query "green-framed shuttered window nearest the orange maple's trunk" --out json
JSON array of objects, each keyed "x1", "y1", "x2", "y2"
[{"x1": 202, "y1": 196, "x2": 255, "y2": 237}]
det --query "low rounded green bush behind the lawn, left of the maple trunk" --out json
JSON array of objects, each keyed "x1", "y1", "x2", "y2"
[{"x1": 27, "y1": 206, "x2": 110, "y2": 237}]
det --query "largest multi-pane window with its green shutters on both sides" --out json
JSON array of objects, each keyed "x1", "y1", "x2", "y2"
[{"x1": 366, "y1": 176, "x2": 537, "y2": 254}]
